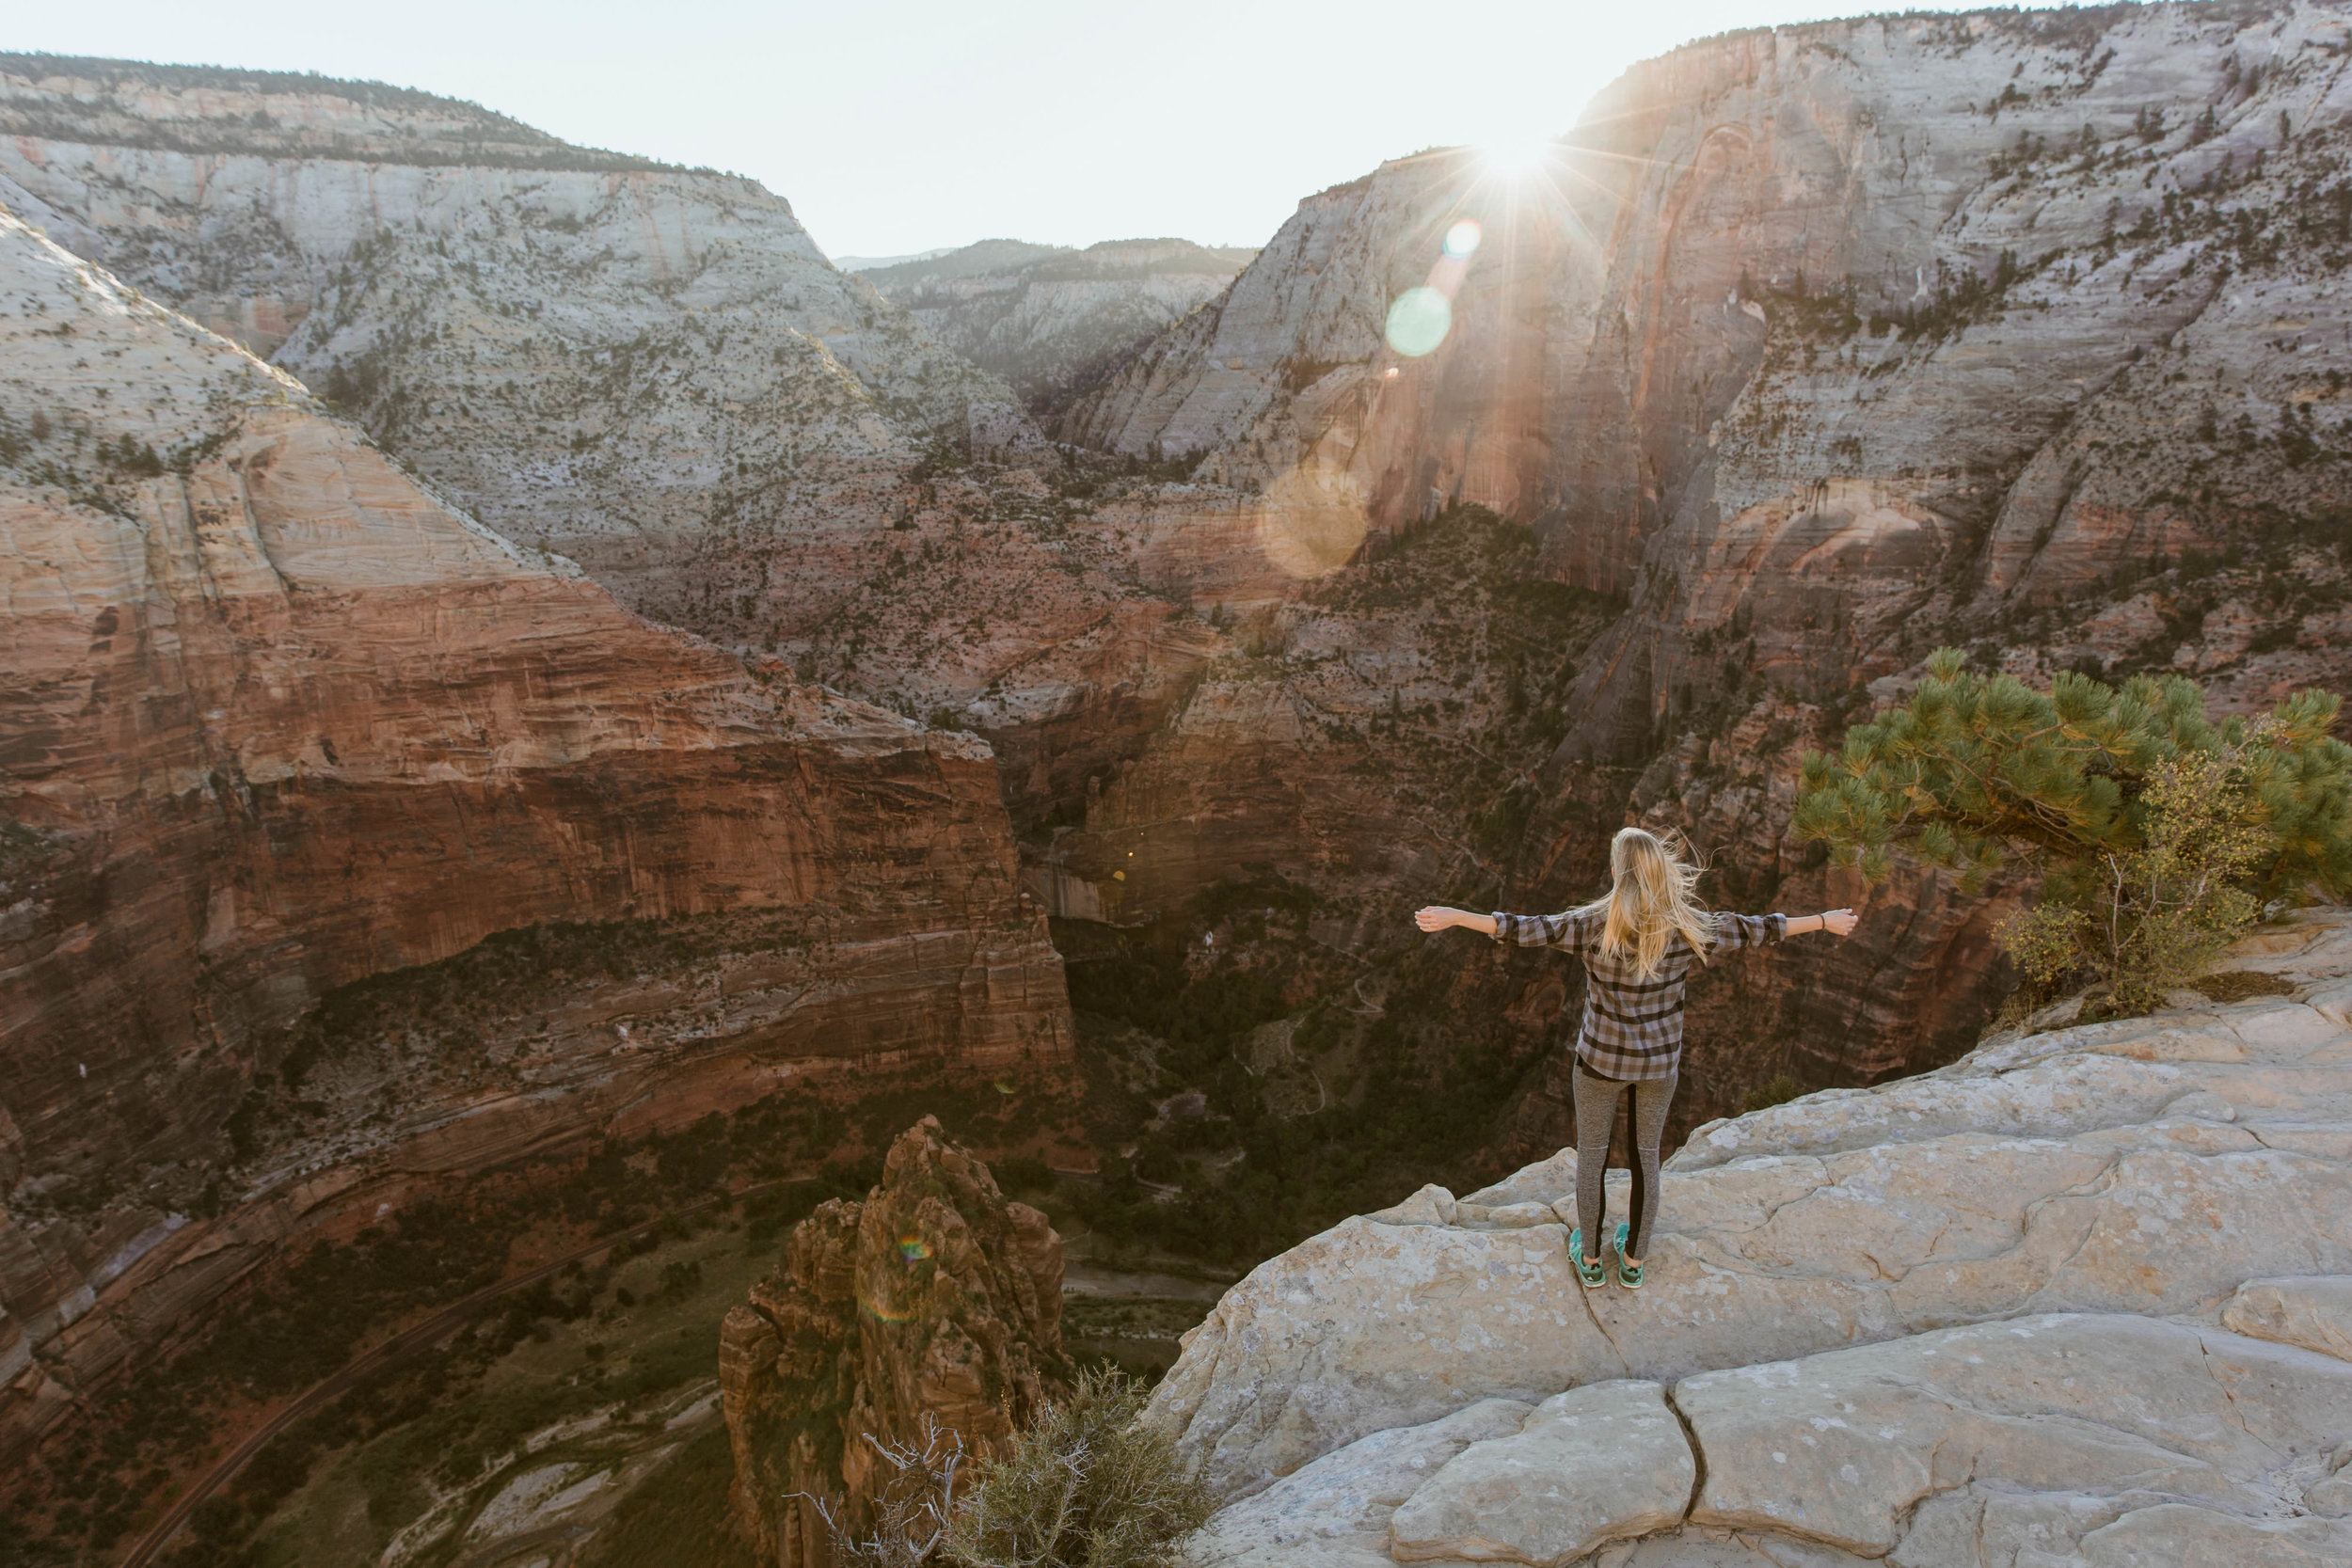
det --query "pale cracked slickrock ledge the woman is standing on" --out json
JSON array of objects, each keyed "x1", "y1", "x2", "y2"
[{"x1": 1176, "y1": 912, "x2": 2352, "y2": 1568}]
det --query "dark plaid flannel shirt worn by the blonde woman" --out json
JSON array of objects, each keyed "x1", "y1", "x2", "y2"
[{"x1": 1494, "y1": 910, "x2": 1788, "y2": 1082}]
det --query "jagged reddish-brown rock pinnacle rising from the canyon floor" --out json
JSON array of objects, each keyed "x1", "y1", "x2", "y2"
[{"x1": 720, "y1": 1117, "x2": 1071, "y2": 1568}]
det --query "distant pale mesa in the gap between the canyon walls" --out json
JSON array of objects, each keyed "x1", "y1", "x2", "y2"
[{"x1": 861, "y1": 240, "x2": 1259, "y2": 416}]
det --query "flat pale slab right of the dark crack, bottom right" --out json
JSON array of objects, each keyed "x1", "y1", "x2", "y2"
[{"x1": 1675, "y1": 1314, "x2": 2352, "y2": 1557}]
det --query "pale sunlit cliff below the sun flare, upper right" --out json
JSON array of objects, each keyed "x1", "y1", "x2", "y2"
[{"x1": 1066, "y1": 7, "x2": 2345, "y2": 759}]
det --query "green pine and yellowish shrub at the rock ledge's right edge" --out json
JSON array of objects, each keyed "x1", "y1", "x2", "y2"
[{"x1": 1792, "y1": 649, "x2": 2352, "y2": 1013}]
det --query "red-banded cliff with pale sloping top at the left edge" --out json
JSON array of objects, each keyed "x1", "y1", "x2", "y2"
[{"x1": 0, "y1": 214, "x2": 1068, "y2": 1453}]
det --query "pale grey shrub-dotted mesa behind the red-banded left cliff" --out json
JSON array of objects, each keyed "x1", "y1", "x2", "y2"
[{"x1": 0, "y1": 56, "x2": 1042, "y2": 646}]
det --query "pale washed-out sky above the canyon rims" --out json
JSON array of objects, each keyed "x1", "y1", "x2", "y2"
[{"x1": 0, "y1": 0, "x2": 1971, "y2": 256}]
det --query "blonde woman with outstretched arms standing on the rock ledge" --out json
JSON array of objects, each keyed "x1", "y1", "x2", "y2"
[{"x1": 1414, "y1": 828, "x2": 1853, "y2": 1291}]
